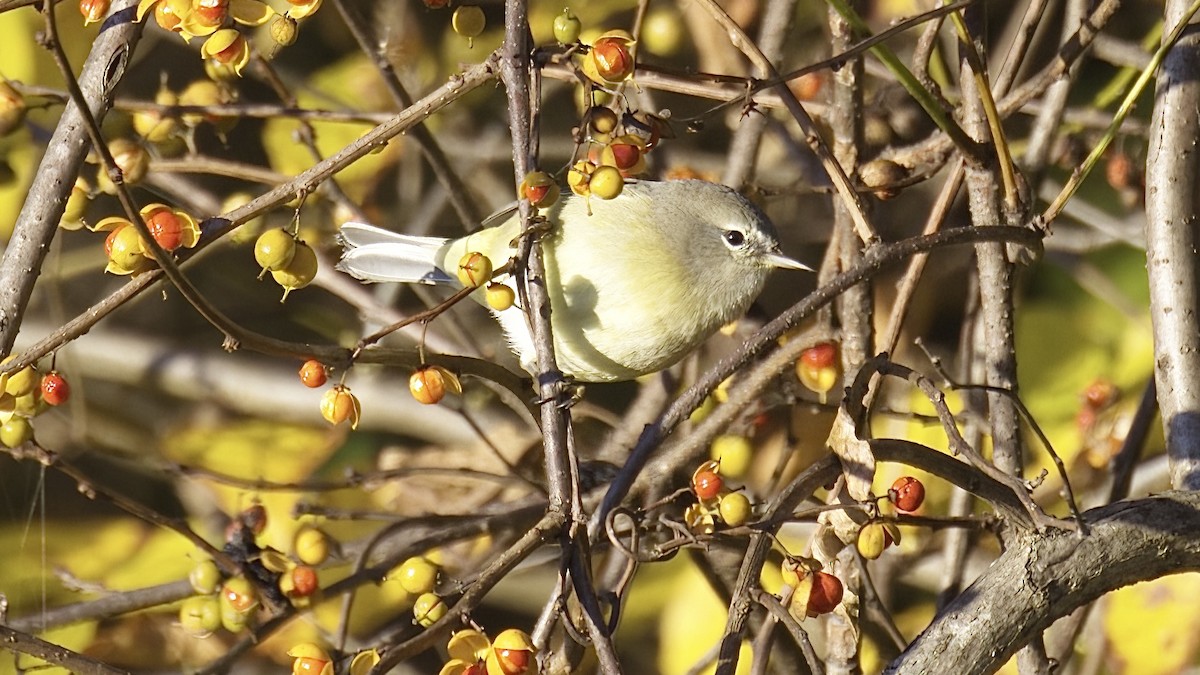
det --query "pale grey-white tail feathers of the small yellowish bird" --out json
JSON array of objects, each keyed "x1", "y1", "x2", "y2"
[{"x1": 337, "y1": 222, "x2": 455, "y2": 283}]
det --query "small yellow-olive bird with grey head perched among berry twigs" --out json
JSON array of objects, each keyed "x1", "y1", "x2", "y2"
[{"x1": 337, "y1": 180, "x2": 810, "y2": 382}]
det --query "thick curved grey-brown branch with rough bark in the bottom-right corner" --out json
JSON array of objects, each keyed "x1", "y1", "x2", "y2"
[{"x1": 884, "y1": 492, "x2": 1200, "y2": 675}]
